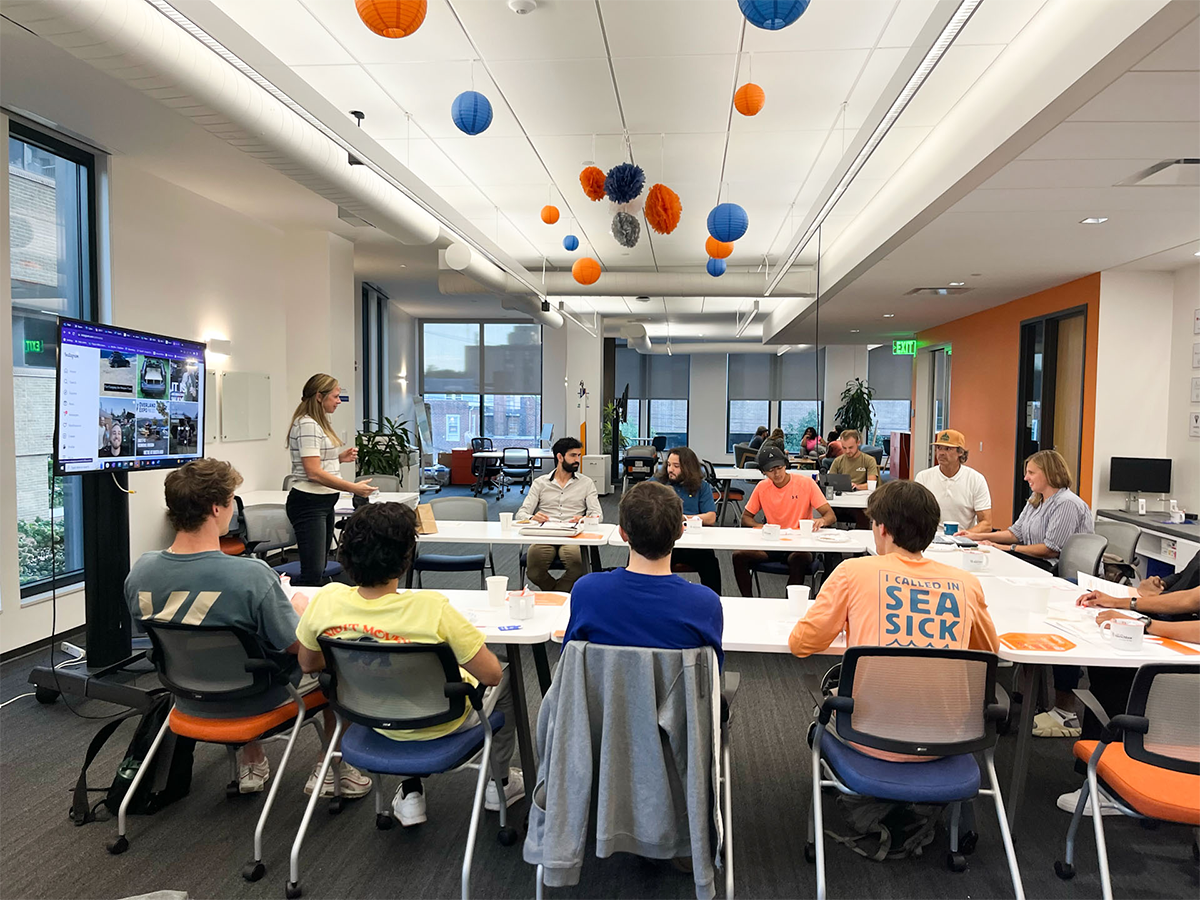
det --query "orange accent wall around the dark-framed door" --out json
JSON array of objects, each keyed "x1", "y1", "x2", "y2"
[{"x1": 913, "y1": 272, "x2": 1100, "y2": 528}]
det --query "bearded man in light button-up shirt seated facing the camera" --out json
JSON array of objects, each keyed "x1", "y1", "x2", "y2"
[{"x1": 517, "y1": 437, "x2": 601, "y2": 590}]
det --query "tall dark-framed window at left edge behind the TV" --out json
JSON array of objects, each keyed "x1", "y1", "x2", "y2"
[{"x1": 8, "y1": 122, "x2": 95, "y2": 596}]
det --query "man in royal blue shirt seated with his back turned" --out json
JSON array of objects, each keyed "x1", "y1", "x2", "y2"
[{"x1": 563, "y1": 481, "x2": 725, "y2": 666}]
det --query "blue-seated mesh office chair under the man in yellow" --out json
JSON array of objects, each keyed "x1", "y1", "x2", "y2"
[{"x1": 286, "y1": 637, "x2": 517, "y2": 900}]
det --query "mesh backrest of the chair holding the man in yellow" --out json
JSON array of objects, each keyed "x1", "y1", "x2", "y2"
[{"x1": 317, "y1": 637, "x2": 467, "y2": 728}]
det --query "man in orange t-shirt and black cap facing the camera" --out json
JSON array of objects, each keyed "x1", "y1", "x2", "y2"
[{"x1": 733, "y1": 444, "x2": 838, "y2": 596}]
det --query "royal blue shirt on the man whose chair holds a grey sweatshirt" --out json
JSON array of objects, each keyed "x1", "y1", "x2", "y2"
[{"x1": 563, "y1": 569, "x2": 725, "y2": 666}]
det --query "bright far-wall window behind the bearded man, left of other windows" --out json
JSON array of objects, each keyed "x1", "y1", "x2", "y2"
[{"x1": 421, "y1": 322, "x2": 541, "y2": 451}]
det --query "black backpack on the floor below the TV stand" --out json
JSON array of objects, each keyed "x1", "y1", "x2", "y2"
[{"x1": 70, "y1": 690, "x2": 196, "y2": 826}]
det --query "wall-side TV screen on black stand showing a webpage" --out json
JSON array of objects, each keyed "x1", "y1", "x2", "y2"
[{"x1": 54, "y1": 319, "x2": 204, "y2": 475}]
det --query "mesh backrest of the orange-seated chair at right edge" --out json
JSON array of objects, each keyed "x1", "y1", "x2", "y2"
[{"x1": 1124, "y1": 662, "x2": 1200, "y2": 775}]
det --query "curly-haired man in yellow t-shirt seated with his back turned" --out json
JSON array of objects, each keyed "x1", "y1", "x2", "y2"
[{"x1": 296, "y1": 503, "x2": 524, "y2": 826}]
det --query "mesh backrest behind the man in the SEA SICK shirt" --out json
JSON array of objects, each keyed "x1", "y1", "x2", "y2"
[{"x1": 838, "y1": 647, "x2": 996, "y2": 756}]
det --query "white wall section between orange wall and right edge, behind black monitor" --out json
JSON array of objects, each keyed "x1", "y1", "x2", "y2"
[{"x1": 1092, "y1": 271, "x2": 1176, "y2": 509}]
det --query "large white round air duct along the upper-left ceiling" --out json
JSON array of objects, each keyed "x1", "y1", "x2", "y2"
[{"x1": 4, "y1": 0, "x2": 442, "y2": 245}]
